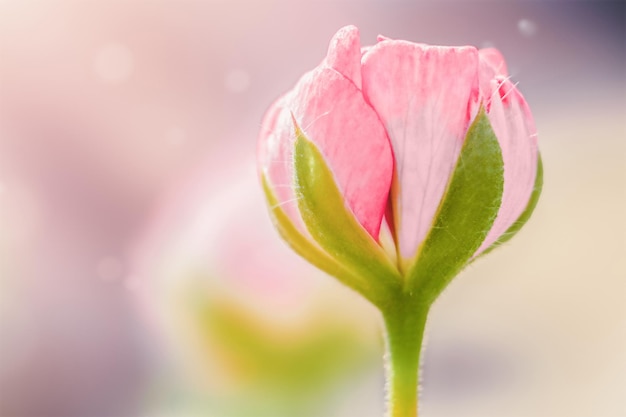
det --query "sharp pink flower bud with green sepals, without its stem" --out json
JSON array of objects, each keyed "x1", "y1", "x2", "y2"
[{"x1": 258, "y1": 26, "x2": 542, "y2": 306}]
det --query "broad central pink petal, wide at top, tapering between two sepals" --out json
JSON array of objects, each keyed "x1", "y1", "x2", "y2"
[{"x1": 363, "y1": 40, "x2": 479, "y2": 259}]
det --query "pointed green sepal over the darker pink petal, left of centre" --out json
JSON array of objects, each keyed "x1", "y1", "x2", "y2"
[{"x1": 294, "y1": 122, "x2": 402, "y2": 306}]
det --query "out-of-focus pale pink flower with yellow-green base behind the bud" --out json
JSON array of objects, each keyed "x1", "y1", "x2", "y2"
[{"x1": 131, "y1": 145, "x2": 380, "y2": 417}]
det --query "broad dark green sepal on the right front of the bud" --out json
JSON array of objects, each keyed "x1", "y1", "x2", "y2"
[{"x1": 405, "y1": 107, "x2": 504, "y2": 302}]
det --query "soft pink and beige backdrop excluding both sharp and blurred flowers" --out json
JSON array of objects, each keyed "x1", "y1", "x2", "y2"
[{"x1": 0, "y1": 0, "x2": 626, "y2": 417}]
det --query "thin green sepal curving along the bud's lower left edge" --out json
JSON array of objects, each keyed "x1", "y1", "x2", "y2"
[{"x1": 261, "y1": 175, "x2": 382, "y2": 302}]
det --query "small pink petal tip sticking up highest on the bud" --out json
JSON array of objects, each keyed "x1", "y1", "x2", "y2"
[{"x1": 326, "y1": 26, "x2": 361, "y2": 89}]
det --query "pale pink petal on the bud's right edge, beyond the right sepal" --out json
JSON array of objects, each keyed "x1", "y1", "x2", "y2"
[{"x1": 475, "y1": 74, "x2": 537, "y2": 256}]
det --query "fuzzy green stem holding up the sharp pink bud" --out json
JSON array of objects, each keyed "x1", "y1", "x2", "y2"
[{"x1": 383, "y1": 296, "x2": 430, "y2": 417}]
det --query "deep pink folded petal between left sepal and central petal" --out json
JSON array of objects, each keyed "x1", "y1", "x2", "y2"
[{"x1": 290, "y1": 68, "x2": 393, "y2": 240}]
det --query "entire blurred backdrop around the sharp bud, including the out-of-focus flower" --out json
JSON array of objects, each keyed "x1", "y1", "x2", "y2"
[{"x1": 0, "y1": 0, "x2": 626, "y2": 417}]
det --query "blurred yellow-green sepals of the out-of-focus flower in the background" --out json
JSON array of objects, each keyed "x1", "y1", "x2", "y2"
[{"x1": 180, "y1": 290, "x2": 376, "y2": 417}]
